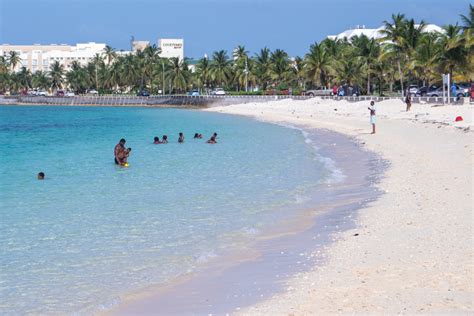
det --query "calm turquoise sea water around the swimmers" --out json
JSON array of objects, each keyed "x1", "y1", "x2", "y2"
[{"x1": 0, "y1": 106, "x2": 333, "y2": 315}]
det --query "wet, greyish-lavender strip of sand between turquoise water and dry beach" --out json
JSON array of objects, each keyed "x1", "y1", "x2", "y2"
[{"x1": 104, "y1": 113, "x2": 385, "y2": 315}]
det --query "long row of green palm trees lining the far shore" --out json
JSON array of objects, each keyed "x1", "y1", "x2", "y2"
[{"x1": 0, "y1": 5, "x2": 474, "y2": 94}]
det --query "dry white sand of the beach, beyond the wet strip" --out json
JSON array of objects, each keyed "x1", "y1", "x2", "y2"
[{"x1": 206, "y1": 99, "x2": 474, "y2": 315}]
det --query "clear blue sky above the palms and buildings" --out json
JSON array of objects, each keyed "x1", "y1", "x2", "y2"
[{"x1": 0, "y1": 0, "x2": 470, "y2": 58}]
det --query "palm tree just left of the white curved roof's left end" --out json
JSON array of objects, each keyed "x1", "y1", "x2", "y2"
[{"x1": 304, "y1": 42, "x2": 331, "y2": 86}]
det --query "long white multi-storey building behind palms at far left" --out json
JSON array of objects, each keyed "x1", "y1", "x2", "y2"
[{"x1": 0, "y1": 42, "x2": 105, "y2": 72}]
